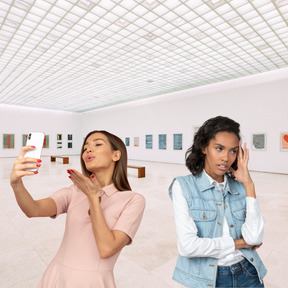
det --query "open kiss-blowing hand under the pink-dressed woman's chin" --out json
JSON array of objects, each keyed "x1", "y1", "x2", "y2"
[{"x1": 67, "y1": 169, "x2": 101, "y2": 197}]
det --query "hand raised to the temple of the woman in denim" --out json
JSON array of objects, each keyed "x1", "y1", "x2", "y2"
[{"x1": 230, "y1": 141, "x2": 252, "y2": 184}]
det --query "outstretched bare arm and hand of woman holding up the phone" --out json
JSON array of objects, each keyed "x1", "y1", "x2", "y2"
[{"x1": 10, "y1": 146, "x2": 57, "y2": 217}]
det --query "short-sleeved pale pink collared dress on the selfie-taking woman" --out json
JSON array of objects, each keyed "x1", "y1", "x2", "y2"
[{"x1": 38, "y1": 184, "x2": 145, "y2": 288}]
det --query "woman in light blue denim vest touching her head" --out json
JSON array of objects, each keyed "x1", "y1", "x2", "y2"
[{"x1": 169, "y1": 116, "x2": 267, "y2": 288}]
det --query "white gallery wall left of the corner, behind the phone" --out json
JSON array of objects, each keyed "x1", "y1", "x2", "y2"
[{"x1": 0, "y1": 105, "x2": 83, "y2": 157}]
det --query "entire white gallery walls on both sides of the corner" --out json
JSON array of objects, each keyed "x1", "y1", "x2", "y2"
[{"x1": 0, "y1": 69, "x2": 288, "y2": 173}]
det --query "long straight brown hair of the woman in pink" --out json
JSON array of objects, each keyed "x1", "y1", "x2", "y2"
[{"x1": 80, "y1": 130, "x2": 132, "y2": 191}]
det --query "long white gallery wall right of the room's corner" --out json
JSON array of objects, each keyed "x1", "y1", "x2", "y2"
[{"x1": 83, "y1": 69, "x2": 288, "y2": 173}]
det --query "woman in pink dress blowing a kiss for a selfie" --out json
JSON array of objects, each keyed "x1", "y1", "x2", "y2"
[{"x1": 10, "y1": 131, "x2": 145, "y2": 288}]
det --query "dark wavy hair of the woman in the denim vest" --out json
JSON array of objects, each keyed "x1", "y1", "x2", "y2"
[{"x1": 185, "y1": 116, "x2": 241, "y2": 179}]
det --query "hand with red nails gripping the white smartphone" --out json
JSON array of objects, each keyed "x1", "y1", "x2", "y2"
[{"x1": 10, "y1": 146, "x2": 41, "y2": 185}]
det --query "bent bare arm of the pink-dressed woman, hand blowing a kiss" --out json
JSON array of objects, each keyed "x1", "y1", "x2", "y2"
[{"x1": 70, "y1": 170, "x2": 131, "y2": 258}]
